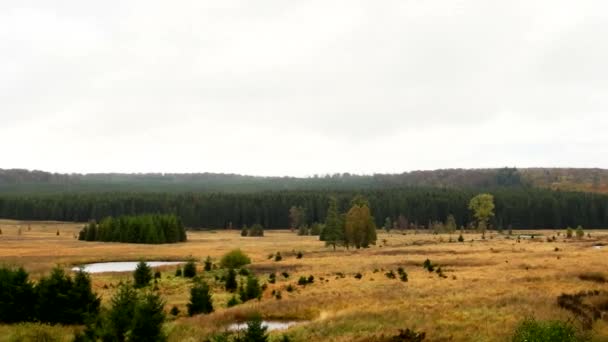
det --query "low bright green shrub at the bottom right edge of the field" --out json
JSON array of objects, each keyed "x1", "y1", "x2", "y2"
[{"x1": 512, "y1": 318, "x2": 588, "y2": 342}]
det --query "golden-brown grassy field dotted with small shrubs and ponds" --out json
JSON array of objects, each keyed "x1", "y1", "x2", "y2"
[{"x1": 0, "y1": 220, "x2": 608, "y2": 341}]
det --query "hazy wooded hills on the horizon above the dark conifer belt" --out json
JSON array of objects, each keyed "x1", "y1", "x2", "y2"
[{"x1": 0, "y1": 168, "x2": 608, "y2": 194}]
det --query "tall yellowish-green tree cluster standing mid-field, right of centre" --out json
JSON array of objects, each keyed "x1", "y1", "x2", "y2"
[{"x1": 319, "y1": 196, "x2": 376, "y2": 249}]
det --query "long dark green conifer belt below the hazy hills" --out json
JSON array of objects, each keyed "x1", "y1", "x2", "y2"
[{"x1": 0, "y1": 188, "x2": 608, "y2": 229}]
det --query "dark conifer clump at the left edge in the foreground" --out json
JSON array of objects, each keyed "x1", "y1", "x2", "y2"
[{"x1": 0, "y1": 267, "x2": 101, "y2": 324}]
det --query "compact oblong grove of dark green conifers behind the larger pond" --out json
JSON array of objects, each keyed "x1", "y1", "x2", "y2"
[{"x1": 78, "y1": 215, "x2": 186, "y2": 244}]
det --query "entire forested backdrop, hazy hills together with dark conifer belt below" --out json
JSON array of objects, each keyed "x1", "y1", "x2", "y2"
[{"x1": 0, "y1": 168, "x2": 608, "y2": 229}]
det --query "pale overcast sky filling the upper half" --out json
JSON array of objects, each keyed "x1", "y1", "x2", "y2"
[{"x1": 0, "y1": 0, "x2": 608, "y2": 176}]
